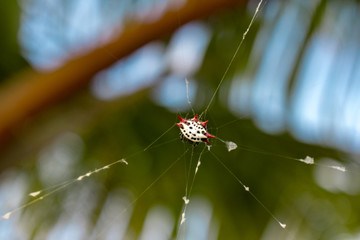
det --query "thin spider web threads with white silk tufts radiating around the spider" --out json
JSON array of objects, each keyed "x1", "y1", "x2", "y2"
[{"x1": 2, "y1": 0, "x2": 346, "y2": 236}]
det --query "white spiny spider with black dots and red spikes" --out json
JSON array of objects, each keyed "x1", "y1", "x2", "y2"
[{"x1": 176, "y1": 114, "x2": 215, "y2": 145}]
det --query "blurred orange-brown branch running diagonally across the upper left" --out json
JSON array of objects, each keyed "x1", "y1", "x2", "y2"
[{"x1": 0, "y1": 0, "x2": 244, "y2": 146}]
